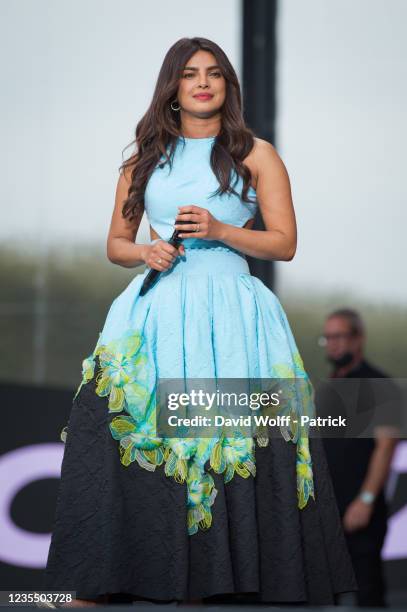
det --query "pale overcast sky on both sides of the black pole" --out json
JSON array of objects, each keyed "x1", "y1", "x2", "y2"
[{"x1": 0, "y1": 0, "x2": 407, "y2": 302}]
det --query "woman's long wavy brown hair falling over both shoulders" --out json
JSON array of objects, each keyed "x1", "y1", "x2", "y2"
[{"x1": 119, "y1": 36, "x2": 255, "y2": 221}]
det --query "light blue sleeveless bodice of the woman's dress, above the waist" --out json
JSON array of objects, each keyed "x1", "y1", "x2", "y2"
[{"x1": 144, "y1": 136, "x2": 257, "y2": 246}]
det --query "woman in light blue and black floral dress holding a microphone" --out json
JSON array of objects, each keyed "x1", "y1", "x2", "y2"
[{"x1": 46, "y1": 38, "x2": 356, "y2": 605}]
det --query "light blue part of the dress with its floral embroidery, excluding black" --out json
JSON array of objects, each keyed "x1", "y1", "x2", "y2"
[{"x1": 74, "y1": 137, "x2": 314, "y2": 524}]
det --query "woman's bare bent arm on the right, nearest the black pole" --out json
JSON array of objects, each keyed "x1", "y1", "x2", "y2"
[{"x1": 219, "y1": 139, "x2": 297, "y2": 261}]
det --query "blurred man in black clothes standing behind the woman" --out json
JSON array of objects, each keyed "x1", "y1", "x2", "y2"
[{"x1": 315, "y1": 308, "x2": 400, "y2": 607}]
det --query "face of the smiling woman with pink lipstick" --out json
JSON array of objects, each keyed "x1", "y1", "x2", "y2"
[{"x1": 177, "y1": 50, "x2": 226, "y2": 117}]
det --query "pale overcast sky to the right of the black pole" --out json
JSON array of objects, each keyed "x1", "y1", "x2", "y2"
[{"x1": 277, "y1": 0, "x2": 407, "y2": 302}]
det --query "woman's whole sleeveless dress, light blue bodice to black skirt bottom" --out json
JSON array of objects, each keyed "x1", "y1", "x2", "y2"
[{"x1": 46, "y1": 137, "x2": 355, "y2": 603}]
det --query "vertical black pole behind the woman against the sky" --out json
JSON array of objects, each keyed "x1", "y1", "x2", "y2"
[{"x1": 242, "y1": 0, "x2": 278, "y2": 289}]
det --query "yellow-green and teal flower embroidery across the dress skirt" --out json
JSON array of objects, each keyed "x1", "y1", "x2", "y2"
[{"x1": 65, "y1": 330, "x2": 315, "y2": 535}]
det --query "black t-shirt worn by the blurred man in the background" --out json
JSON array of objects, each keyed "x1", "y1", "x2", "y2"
[{"x1": 315, "y1": 359, "x2": 401, "y2": 552}]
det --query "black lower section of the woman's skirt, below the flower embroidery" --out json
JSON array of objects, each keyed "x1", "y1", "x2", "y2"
[{"x1": 44, "y1": 381, "x2": 357, "y2": 605}]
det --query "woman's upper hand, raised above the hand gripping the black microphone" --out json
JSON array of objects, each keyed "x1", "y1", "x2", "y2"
[{"x1": 174, "y1": 204, "x2": 224, "y2": 240}]
